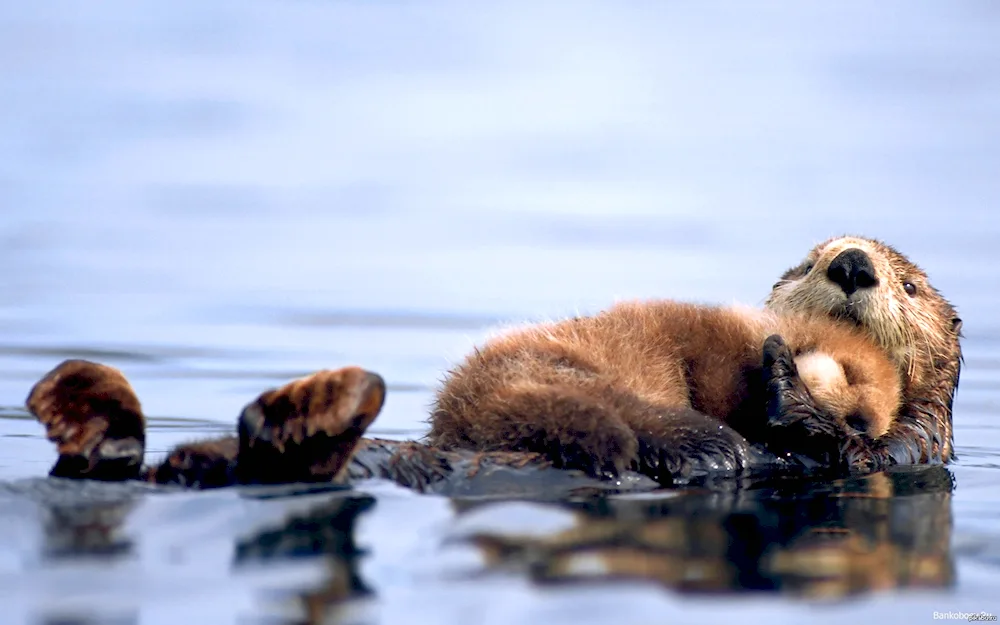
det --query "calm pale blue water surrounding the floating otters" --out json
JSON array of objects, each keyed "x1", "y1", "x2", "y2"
[{"x1": 0, "y1": 0, "x2": 1000, "y2": 624}]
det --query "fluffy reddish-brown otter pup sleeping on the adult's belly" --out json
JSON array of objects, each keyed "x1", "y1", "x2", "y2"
[{"x1": 428, "y1": 301, "x2": 900, "y2": 479}]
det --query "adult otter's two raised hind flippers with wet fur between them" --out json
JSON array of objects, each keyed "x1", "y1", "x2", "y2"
[{"x1": 27, "y1": 360, "x2": 385, "y2": 488}]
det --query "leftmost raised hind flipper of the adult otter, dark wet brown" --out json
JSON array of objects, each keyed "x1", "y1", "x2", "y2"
[{"x1": 26, "y1": 360, "x2": 146, "y2": 481}]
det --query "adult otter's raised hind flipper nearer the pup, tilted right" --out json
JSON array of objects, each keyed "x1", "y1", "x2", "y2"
[{"x1": 236, "y1": 367, "x2": 385, "y2": 484}]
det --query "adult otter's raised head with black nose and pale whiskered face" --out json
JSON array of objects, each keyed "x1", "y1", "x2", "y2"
[{"x1": 766, "y1": 237, "x2": 962, "y2": 459}]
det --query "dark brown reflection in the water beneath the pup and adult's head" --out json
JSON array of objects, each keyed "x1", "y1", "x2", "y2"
[{"x1": 459, "y1": 466, "x2": 955, "y2": 597}]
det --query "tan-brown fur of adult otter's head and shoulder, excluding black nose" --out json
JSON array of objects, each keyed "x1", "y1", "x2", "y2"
[{"x1": 767, "y1": 237, "x2": 962, "y2": 464}]
